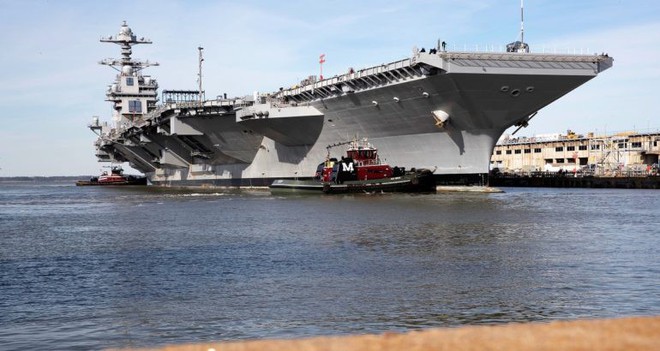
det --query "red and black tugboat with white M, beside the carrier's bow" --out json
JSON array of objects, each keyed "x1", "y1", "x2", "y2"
[{"x1": 270, "y1": 139, "x2": 435, "y2": 194}]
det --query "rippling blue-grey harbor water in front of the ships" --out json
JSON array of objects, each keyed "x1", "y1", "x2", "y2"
[{"x1": 0, "y1": 181, "x2": 660, "y2": 350}]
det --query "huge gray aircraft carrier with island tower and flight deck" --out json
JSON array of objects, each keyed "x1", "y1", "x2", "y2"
[{"x1": 89, "y1": 22, "x2": 613, "y2": 186}]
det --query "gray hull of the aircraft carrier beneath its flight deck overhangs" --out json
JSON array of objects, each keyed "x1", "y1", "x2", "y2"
[{"x1": 147, "y1": 65, "x2": 608, "y2": 185}]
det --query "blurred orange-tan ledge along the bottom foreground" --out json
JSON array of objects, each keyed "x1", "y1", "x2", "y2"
[{"x1": 116, "y1": 316, "x2": 660, "y2": 351}]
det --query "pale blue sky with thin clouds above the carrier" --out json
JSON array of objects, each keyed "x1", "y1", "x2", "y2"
[{"x1": 0, "y1": 0, "x2": 660, "y2": 176}]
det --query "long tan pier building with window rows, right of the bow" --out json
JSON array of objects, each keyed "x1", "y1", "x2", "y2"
[{"x1": 491, "y1": 130, "x2": 660, "y2": 177}]
